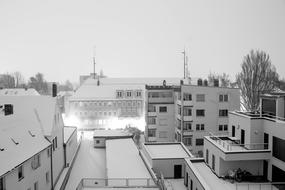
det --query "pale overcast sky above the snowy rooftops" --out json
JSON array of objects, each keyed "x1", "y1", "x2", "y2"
[{"x1": 0, "y1": 0, "x2": 285, "y2": 82}]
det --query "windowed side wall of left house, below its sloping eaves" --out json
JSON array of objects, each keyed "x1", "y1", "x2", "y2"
[{"x1": 4, "y1": 149, "x2": 51, "y2": 190}]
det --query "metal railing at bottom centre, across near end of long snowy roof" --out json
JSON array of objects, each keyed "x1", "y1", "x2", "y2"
[{"x1": 76, "y1": 178, "x2": 157, "y2": 190}]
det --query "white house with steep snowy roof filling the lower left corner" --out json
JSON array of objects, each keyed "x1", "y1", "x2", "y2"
[{"x1": 0, "y1": 95, "x2": 64, "y2": 190}]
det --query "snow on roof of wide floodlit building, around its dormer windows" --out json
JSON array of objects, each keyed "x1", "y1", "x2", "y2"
[{"x1": 70, "y1": 83, "x2": 145, "y2": 100}]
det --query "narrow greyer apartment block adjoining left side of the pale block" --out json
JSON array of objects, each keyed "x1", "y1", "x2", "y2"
[{"x1": 145, "y1": 85, "x2": 178, "y2": 142}]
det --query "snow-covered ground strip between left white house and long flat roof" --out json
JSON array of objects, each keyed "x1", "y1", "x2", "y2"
[{"x1": 65, "y1": 131, "x2": 107, "y2": 190}]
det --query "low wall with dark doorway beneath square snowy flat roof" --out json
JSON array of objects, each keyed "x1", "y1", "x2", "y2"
[{"x1": 152, "y1": 159, "x2": 185, "y2": 178}]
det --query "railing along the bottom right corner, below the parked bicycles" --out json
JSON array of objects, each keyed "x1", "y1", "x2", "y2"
[{"x1": 236, "y1": 182, "x2": 285, "y2": 190}]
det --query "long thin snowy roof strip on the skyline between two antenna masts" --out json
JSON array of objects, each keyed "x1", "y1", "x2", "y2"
[{"x1": 83, "y1": 77, "x2": 183, "y2": 85}]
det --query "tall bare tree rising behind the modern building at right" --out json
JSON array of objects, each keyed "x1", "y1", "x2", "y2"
[{"x1": 236, "y1": 50, "x2": 279, "y2": 111}]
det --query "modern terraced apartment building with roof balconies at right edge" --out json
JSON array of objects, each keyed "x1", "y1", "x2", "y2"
[{"x1": 199, "y1": 92, "x2": 285, "y2": 189}]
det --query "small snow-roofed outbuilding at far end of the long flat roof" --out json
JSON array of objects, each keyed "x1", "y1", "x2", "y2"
[{"x1": 93, "y1": 129, "x2": 133, "y2": 148}]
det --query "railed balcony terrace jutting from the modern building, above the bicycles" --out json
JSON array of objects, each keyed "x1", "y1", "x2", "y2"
[{"x1": 204, "y1": 136, "x2": 271, "y2": 161}]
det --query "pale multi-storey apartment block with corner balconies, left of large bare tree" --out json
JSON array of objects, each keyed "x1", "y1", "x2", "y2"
[{"x1": 174, "y1": 79, "x2": 240, "y2": 157}]
